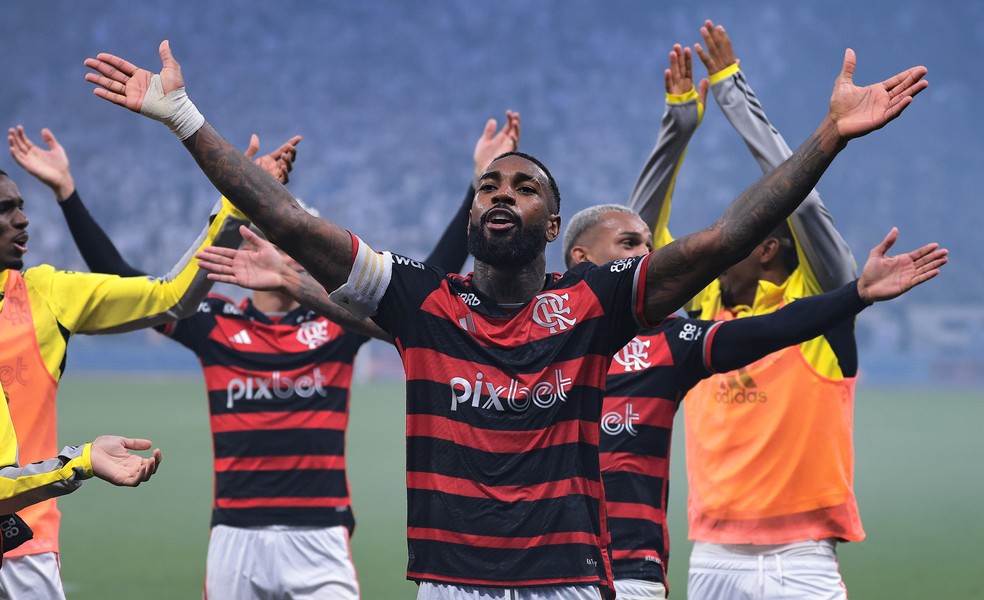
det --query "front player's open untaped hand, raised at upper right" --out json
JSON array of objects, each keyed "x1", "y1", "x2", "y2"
[{"x1": 830, "y1": 48, "x2": 929, "y2": 140}]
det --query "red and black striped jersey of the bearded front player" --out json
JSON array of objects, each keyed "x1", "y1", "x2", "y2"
[{"x1": 373, "y1": 255, "x2": 646, "y2": 588}]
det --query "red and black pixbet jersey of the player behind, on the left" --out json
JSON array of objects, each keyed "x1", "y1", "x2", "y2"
[{"x1": 164, "y1": 295, "x2": 368, "y2": 529}]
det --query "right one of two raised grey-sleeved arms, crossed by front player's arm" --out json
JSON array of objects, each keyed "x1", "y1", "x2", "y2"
[{"x1": 695, "y1": 20, "x2": 857, "y2": 293}]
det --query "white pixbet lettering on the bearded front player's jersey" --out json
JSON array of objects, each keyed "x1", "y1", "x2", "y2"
[{"x1": 449, "y1": 369, "x2": 573, "y2": 412}]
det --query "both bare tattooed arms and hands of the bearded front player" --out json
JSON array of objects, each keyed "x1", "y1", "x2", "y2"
[{"x1": 85, "y1": 41, "x2": 928, "y2": 323}]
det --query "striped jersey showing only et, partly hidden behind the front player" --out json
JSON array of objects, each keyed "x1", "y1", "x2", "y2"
[{"x1": 600, "y1": 317, "x2": 713, "y2": 583}]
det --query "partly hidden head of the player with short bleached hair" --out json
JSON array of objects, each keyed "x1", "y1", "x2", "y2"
[{"x1": 571, "y1": 212, "x2": 653, "y2": 265}]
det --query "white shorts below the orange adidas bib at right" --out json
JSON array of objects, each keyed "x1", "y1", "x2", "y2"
[{"x1": 687, "y1": 539, "x2": 847, "y2": 600}]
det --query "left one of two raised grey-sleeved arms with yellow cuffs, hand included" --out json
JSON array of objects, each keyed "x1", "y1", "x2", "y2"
[{"x1": 628, "y1": 44, "x2": 708, "y2": 248}]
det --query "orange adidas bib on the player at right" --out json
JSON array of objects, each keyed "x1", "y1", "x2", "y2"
[{"x1": 684, "y1": 315, "x2": 864, "y2": 544}]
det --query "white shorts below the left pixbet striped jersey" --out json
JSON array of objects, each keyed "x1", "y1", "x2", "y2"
[{"x1": 205, "y1": 525, "x2": 359, "y2": 600}]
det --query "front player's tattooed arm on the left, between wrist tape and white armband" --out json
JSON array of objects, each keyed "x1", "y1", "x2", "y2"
[{"x1": 184, "y1": 123, "x2": 352, "y2": 289}]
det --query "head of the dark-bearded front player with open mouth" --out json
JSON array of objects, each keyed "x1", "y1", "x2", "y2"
[{"x1": 468, "y1": 156, "x2": 560, "y2": 266}]
